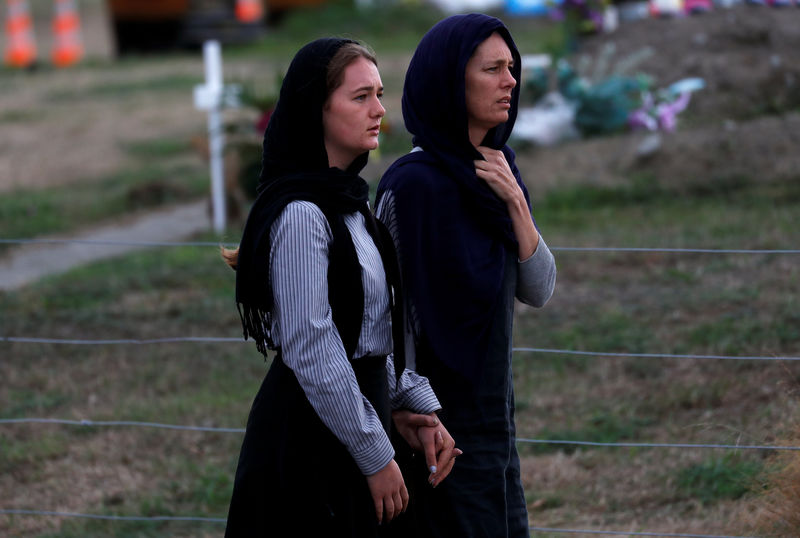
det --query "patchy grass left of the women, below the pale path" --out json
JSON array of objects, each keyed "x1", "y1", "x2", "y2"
[{"x1": 0, "y1": 241, "x2": 250, "y2": 537}]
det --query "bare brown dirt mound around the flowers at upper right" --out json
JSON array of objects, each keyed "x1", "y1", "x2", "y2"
[{"x1": 521, "y1": 6, "x2": 800, "y2": 193}]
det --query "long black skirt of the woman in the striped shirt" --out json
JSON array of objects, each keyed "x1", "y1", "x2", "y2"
[{"x1": 225, "y1": 354, "x2": 390, "y2": 538}]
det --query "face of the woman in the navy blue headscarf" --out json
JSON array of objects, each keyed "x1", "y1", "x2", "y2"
[{"x1": 465, "y1": 33, "x2": 517, "y2": 131}]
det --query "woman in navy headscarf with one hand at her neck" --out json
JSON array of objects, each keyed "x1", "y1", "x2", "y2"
[{"x1": 377, "y1": 14, "x2": 556, "y2": 538}]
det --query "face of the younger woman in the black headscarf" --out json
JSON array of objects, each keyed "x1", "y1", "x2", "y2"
[{"x1": 322, "y1": 58, "x2": 386, "y2": 170}]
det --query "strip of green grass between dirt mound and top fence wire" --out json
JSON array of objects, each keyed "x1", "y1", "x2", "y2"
[{"x1": 534, "y1": 172, "x2": 800, "y2": 249}]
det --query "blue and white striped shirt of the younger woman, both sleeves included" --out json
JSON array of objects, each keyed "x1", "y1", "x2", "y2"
[{"x1": 270, "y1": 201, "x2": 441, "y2": 475}]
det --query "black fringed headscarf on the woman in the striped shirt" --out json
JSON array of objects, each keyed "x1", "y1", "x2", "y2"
[{"x1": 236, "y1": 38, "x2": 403, "y2": 376}]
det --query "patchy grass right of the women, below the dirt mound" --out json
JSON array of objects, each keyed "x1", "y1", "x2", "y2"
[{"x1": 506, "y1": 166, "x2": 800, "y2": 535}]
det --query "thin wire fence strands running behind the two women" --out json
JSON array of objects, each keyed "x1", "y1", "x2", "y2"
[{"x1": 0, "y1": 238, "x2": 800, "y2": 538}]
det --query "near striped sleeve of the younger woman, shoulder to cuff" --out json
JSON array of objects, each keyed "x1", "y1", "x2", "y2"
[{"x1": 270, "y1": 202, "x2": 394, "y2": 475}]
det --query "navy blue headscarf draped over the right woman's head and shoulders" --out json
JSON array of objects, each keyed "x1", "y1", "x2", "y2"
[{"x1": 377, "y1": 13, "x2": 530, "y2": 381}]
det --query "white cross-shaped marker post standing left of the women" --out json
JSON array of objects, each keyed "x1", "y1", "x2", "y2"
[{"x1": 194, "y1": 41, "x2": 225, "y2": 233}]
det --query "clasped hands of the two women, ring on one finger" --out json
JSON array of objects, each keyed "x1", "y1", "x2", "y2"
[{"x1": 392, "y1": 409, "x2": 463, "y2": 486}]
